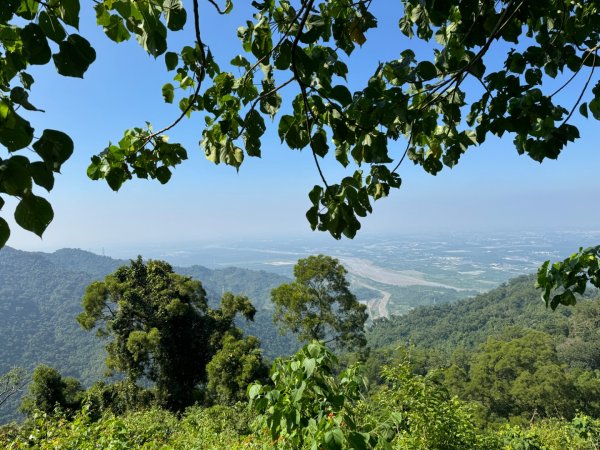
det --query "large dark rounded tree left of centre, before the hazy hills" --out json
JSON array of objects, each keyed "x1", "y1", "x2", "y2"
[{"x1": 77, "y1": 257, "x2": 262, "y2": 411}]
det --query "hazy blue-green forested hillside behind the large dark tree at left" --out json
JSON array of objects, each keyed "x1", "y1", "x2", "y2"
[{"x1": 0, "y1": 247, "x2": 298, "y2": 422}]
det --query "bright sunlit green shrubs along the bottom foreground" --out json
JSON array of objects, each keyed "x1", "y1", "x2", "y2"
[{"x1": 0, "y1": 342, "x2": 600, "y2": 450}]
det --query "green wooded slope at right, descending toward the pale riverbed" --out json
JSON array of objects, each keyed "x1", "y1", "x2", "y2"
[{"x1": 367, "y1": 276, "x2": 600, "y2": 424}]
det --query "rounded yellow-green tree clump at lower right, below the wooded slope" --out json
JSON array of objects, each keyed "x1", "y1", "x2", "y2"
[{"x1": 444, "y1": 330, "x2": 600, "y2": 424}]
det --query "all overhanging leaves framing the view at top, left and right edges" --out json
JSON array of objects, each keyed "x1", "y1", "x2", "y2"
[{"x1": 0, "y1": 0, "x2": 600, "y2": 300}]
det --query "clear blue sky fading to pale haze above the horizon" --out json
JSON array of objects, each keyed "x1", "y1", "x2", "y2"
[{"x1": 2, "y1": 1, "x2": 600, "y2": 251}]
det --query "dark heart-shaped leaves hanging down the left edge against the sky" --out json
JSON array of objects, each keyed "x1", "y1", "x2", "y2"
[{"x1": 0, "y1": 0, "x2": 96, "y2": 248}]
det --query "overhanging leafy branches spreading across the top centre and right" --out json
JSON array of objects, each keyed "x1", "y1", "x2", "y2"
[{"x1": 90, "y1": 0, "x2": 600, "y2": 243}]
